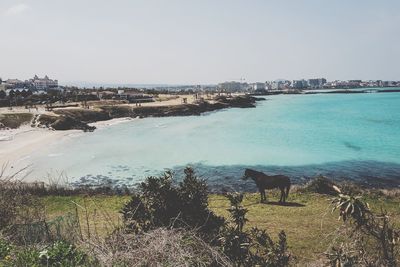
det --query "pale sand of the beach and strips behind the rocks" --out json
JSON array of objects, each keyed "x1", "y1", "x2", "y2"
[{"x1": 0, "y1": 95, "x2": 248, "y2": 180}]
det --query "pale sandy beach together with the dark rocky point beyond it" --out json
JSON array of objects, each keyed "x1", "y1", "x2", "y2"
[{"x1": 0, "y1": 96, "x2": 263, "y2": 180}]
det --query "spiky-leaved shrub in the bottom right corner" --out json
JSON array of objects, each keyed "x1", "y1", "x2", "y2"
[{"x1": 327, "y1": 187, "x2": 400, "y2": 266}]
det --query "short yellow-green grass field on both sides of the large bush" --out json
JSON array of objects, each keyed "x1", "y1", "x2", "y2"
[{"x1": 42, "y1": 192, "x2": 400, "y2": 263}]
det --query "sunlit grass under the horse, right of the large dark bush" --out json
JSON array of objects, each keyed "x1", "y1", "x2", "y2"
[{"x1": 210, "y1": 191, "x2": 400, "y2": 265}]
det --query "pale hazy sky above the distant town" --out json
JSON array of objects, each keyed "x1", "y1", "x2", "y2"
[{"x1": 0, "y1": 0, "x2": 400, "y2": 84}]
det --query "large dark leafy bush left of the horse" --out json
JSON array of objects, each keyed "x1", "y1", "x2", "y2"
[{"x1": 121, "y1": 168, "x2": 224, "y2": 239}]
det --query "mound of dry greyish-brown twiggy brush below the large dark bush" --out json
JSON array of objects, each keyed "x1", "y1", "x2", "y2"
[{"x1": 90, "y1": 228, "x2": 232, "y2": 266}]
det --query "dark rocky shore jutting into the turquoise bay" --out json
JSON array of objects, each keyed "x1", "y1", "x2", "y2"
[{"x1": 35, "y1": 95, "x2": 265, "y2": 131}]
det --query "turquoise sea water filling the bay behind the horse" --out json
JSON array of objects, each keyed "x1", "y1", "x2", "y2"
[{"x1": 28, "y1": 93, "x2": 400, "y2": 190}]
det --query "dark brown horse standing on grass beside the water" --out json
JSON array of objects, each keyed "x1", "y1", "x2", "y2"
[{"x1": 242, "y1": 169, "x2": 290, "y2": 203}]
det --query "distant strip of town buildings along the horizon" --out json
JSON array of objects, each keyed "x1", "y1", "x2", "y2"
[{"x1": 0, "y1": 74, "x2": 400, "y2": 93}]
